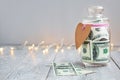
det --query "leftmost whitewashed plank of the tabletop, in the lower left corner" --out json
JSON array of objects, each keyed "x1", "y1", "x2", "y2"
[{"x1": 0, "y1": 47, "x2": 26, "y2": 80}]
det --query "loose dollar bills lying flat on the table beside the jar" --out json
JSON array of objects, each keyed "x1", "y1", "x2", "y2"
[{"x1": 53, "y1": 63, "x2": 94, "y2": 76}]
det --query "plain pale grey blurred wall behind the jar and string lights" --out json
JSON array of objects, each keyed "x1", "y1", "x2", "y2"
[{"x1": 0, "y1": 0, "x2": 120, "y2": 46}]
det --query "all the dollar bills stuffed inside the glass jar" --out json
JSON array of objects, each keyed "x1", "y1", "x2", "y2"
[{"x1": 81, "y1": 27, "x2": 110, "y2": 63}]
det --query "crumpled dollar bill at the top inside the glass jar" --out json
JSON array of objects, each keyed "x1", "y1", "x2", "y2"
[{"x1": 89, "y1": 27, "x2": 109, "y2": 41}]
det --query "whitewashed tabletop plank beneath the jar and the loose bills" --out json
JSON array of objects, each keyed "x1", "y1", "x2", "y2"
[{"x1": 47, "y1": 50, "x2": 120, "y2": 80}]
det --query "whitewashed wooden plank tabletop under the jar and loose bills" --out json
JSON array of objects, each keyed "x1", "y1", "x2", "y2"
[{"x1": 0, "y1": 46, "x2": 120, "y2": 80}]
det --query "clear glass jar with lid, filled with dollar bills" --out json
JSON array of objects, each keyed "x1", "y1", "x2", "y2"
[{"x1": 81, "y1": 6, "x2": 110, "y2": 65}]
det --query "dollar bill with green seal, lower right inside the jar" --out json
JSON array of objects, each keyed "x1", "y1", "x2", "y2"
[{"x1": 92, "y1": 41, "x2": 110, "y2": 62}]
